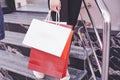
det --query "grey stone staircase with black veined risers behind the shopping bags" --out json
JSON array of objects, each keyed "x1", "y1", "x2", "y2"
[{"x1": 0, "y1": 12, "x2": 88, "y2": 80}]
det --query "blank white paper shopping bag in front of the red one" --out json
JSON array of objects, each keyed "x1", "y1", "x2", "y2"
[{"x1": 23, "y1": 19, "x2": 71, "y2": 57}]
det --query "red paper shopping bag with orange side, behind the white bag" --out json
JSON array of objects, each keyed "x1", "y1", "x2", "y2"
[{"x1": 28, "y1": 25, "x2": 73, "y2": 78}]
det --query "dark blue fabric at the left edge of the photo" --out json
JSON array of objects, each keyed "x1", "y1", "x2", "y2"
[{"x1": 0, "y1": 6, "x2": 5, "y2": 40}]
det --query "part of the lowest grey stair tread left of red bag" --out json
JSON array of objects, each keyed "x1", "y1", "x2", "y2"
[{"x1": 0, "y1": 50, "x2": 35, "y2": 78}]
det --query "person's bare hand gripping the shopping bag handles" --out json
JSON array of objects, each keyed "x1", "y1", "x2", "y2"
[{"x1": 50, "y1": 0, "x2": 61, "y2": 12}]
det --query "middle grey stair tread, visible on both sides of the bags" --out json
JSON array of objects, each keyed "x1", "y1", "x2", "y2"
[{"x1": 1, "y1": 31, "x2": 92, "y2": 60}]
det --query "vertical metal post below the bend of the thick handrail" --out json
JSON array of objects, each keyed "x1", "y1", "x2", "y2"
[{"x1": 102, "y1": 22, "x2": 111, "y2": 80}]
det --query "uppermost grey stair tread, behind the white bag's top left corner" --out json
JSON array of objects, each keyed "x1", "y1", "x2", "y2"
[{"x1": 4, "y1": 12, "x2": 48, "y2": 25}]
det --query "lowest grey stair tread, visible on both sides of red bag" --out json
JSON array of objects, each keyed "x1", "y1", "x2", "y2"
[{"x1": 0, "y1": 50, "x2": 87, "y2": 80}]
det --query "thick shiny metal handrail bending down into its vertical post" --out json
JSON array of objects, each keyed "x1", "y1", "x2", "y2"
[{"x1": 95, "y1": 0, "x2": 111, "y2": 80}]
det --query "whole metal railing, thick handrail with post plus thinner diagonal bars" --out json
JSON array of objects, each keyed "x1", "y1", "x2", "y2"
[{"x1": 81, "y1": 0, "x2": 111, "y2": 80}]
